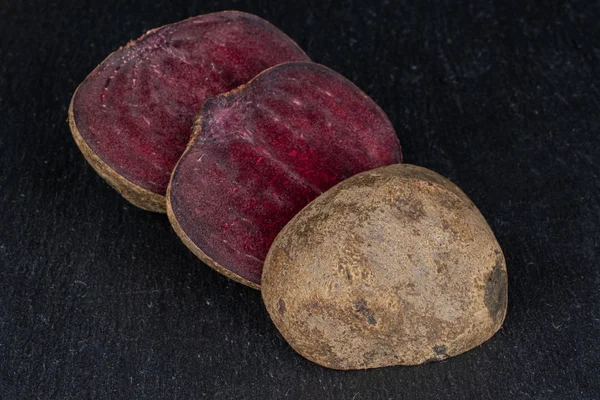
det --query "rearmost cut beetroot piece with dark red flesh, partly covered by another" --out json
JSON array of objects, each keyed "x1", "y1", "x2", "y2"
[{"x1": 69, "y1": 11, "x2": 308, "y2": 212}]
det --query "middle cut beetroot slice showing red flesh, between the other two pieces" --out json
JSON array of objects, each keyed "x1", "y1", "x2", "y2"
[{"x1": 167, "y1": 63, "x2": 401, "y2": 288}]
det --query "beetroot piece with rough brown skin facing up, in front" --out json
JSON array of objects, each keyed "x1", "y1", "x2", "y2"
[{"x1": 262, "y1": 164, "x2": 508, "y2": 369}]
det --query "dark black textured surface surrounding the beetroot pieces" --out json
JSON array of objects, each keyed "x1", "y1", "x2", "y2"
[{"x1": 0, "y1": 0, "x2": 600, "y2": 400}]
